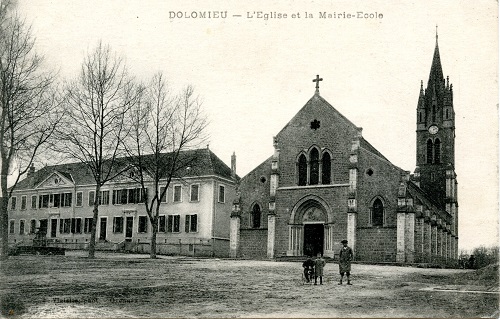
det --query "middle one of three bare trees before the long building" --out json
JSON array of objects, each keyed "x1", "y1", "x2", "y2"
[{"x1": 57, "y1": 42, "x2": 142, "y2": 258}]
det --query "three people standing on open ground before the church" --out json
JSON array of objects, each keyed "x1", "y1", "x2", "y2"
[{"x1": 302, "y1": 239, "x2": 353, "y2": 285}]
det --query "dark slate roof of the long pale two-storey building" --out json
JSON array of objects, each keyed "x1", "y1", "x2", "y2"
[{"x1": 16, "y1": 148, "x2": 238, "y2": 190}]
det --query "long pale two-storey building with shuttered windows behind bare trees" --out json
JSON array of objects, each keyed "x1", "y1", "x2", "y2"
[{"x1": 9, "y1": 148, "x2": 237, "y2": 257}]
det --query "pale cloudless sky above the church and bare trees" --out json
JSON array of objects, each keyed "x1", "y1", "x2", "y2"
[{"x1": 14, "y1": 0, "x2": 498, "y2": 250}]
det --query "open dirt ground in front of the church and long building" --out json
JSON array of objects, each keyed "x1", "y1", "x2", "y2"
[{"x1": 0, "y1": 252, "x2": 499, "y2": 318}]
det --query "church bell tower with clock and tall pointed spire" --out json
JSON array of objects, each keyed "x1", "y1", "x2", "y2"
[{"x1": 415, "y1": 32, "x2": 458, "y2": 238}]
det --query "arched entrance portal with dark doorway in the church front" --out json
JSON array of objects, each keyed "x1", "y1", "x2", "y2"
[{"x1": 287, "y1": 197, "x2": 333, "y2": 256}]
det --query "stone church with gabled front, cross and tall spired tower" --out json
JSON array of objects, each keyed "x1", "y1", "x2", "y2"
[{"x1": 230, "y1": 35, "x2": 458, "y2": 266}]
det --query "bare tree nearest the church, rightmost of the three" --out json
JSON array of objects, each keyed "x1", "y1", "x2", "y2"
[{"x1": 125, "y1": 73, "x2": 207, "y2": 258}]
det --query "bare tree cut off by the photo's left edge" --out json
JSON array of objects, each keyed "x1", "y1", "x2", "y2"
[{"x1": 0, "y1": 9, "x2": 62, "y2": 259}]
